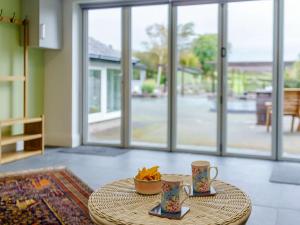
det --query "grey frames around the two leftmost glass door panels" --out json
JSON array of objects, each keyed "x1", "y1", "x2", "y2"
[{"x1": 81, "y1": 3, "x2": 172, "y2": 151}]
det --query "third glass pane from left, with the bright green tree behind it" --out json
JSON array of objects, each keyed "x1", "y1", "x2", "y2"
[{"x1": 177, "y1": 4, "x2": 218, "y2": 151}]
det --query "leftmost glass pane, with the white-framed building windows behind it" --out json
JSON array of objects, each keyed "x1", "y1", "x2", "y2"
[{"x1": 87, "y1": 8, "x2": 122, "y2": 144}]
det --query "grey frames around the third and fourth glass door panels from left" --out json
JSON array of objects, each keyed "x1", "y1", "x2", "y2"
[{"x1": 171, "y1": 0, "x2": 281, "y2": 160}]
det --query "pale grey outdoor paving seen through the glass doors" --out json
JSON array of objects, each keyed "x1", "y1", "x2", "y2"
[{"x1": 89, "y1": 95, "x2": 300, "y2": 155}]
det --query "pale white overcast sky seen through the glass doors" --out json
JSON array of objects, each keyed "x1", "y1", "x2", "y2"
[{"x1": 89, "y1": 0, "x2": 300, "y2": 61}]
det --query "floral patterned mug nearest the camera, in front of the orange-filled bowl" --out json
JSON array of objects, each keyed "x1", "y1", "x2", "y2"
[{"x1": 161, "y1": 176, "x2": 191, "y2": 213}]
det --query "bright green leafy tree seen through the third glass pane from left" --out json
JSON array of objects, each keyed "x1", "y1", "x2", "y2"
[{"x1": 192, "y1": 34, "x2": 218, "y2": 92}]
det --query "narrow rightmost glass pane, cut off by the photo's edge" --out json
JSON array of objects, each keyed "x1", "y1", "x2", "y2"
[{"x1": 282, "y1": 0, "x2": 300, "y2": 157}]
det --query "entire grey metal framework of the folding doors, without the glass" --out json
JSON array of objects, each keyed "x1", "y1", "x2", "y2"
[{"x1": 82, "y1": 0, "x2": 300, "y2": 161}]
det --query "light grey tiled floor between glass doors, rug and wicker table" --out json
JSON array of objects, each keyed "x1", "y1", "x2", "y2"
[{"x1": 0, "y1": 149, "x2": 300, "y2": 225}]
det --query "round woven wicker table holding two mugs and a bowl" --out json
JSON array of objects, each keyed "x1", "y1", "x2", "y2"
[{"x1": 88, "y1": 175, "x2": 251, "y2": 225}]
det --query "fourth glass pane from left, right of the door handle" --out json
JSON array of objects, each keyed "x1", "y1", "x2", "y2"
[{"x1": 227, "y1": 0, "x2": 273, "y2": 155}]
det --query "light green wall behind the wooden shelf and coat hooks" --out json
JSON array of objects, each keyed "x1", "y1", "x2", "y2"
[{"x1": 0, "y1": 0, "x2": 44, "y2": 126}]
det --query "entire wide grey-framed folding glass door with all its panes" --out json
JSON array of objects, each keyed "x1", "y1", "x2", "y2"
[{"x1": 83, "y1": 0, "x2": 300, "y2": 162}]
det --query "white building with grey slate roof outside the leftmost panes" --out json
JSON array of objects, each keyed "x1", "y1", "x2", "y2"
[{"x1": 88, "y1": 38, "x2": 146, "y2": 123}]
